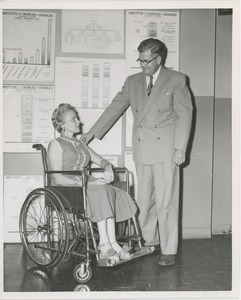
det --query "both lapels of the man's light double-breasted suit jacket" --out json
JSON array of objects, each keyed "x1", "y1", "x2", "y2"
[{"x1": 140, "y1": 66, "x2": 166, "y2": 122}]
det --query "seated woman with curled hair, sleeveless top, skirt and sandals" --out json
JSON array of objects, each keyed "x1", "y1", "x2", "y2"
[{"x1": 48, "y1": 103, "x2": 137, "y2": 260}]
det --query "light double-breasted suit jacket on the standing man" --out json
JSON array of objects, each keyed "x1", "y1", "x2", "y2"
[{"x1": 90, "y1": 66, "x2": 192, "y2": 164}]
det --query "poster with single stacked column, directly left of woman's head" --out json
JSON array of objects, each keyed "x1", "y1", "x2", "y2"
[{"x1": 3, "y1": 84, "x2": 55, "y2": 152}]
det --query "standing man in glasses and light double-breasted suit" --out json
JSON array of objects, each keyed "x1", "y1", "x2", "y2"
[{"x1": 81, "y1": 38, "x2": 192, "y2": 266}]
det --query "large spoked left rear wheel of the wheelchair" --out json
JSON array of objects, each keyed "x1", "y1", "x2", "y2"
[{"x1": 19, "y1": 188, "x2": 69, "y2": 267}]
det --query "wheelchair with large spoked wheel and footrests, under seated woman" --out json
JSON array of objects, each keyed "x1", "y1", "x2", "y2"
[{"x1": 19, "y1": 144, "x2": 154, "y2": 283}]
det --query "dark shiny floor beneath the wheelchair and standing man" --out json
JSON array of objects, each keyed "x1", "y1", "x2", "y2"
[{"x1": 4, "y1": 235, "x2": 232, "y2": 292}]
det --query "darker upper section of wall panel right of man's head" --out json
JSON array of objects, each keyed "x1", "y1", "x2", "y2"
[{"x1": 180, "y1": 9, "x2": 215, "y2": 96}]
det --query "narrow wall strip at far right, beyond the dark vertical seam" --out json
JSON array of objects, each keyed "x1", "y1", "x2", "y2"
[{"x1": 212, "y1": 15, "x2": 233, "y2": 234}]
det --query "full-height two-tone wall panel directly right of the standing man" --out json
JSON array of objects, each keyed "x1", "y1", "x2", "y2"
[{"x1": 180, "y1": 9, "x2": 215, "y2": 238}]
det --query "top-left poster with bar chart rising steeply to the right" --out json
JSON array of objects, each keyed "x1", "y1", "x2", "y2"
[{"x1": 2, "y1": 10, "x2": 55, "y2": 82}]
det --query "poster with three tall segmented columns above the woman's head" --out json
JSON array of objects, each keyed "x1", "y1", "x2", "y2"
[{"x1": 55, "y1": 57, "x2": 125, "y2": 109}]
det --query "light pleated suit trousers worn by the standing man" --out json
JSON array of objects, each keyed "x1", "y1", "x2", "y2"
[{"x1": 136, "y1": 162, "x2": 180, "y2": 254}]
